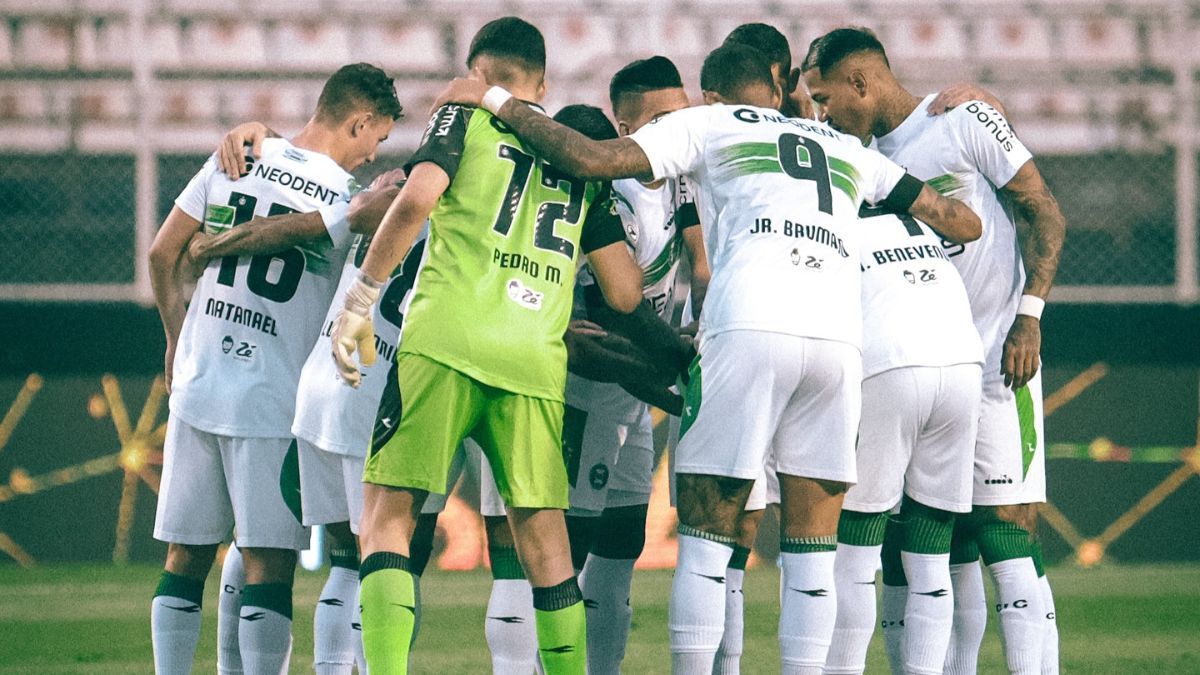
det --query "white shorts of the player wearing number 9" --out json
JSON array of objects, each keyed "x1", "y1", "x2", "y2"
[{"x1": 676, "y1": 330, "x2": 863, "y2": 483}]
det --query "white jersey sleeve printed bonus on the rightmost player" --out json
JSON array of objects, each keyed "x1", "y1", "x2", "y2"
[{"x1": 947, "y1": 101, "x2": 1033, "y2": 187}]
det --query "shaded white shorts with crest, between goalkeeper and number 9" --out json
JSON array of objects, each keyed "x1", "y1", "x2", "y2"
[{"x1": 563, "y1": 407, "x2": 654, "y2": 516}]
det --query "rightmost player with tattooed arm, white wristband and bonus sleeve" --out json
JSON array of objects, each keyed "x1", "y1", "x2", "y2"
[{"x1": 803, "y1": 29, "x2": 1066, "y2": 673}]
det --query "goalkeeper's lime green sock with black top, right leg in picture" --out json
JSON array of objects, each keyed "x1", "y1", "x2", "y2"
[{"x1": 535, "y1": 577, "x2": 588, "y2": 675}]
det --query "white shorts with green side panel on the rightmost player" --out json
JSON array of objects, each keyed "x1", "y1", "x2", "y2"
[{"x1": 971, "y1": 370, "x2": 1046, "y2": 506}]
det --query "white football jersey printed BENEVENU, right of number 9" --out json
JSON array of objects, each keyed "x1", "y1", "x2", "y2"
[{"x1": 860, "y1": 209, "x2": 983, "y2": 378}]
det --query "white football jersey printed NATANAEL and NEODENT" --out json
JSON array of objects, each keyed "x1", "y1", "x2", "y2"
[{"x1": 170, "y1": 138, "x2": 356, "y2": 438}]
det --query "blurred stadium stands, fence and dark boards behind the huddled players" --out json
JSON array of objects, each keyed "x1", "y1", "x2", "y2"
[{"x1": 0, "y1": 0, "x2": 1200, "y2": 671}]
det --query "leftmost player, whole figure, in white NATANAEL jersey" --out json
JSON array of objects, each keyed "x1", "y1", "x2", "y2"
[{"x1": 150, "y1": 64, "x2": 401, "y2": 673}]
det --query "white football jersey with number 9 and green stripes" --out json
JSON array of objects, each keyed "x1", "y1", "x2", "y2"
[{"x1": 630, "y1": 104, "x2": 904, "y2": 347}]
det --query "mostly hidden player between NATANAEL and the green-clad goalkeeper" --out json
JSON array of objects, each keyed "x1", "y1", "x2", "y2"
[{"x1": 188, "y1": 164, "x2": 408, "y2": 675}]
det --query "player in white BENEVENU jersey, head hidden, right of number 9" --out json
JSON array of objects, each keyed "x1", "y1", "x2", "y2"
[{"x1": 824, "y1": 196, "x2": 983, "y2": 675}]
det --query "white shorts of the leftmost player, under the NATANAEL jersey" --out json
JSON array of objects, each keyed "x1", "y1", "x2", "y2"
[{"x1": 154, "y1": 417, "x2": 308, "y2": 550}]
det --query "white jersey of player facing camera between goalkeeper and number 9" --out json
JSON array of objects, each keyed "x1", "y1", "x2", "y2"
[{"x1": 566, "y1": 178, "x2": 698, "y2": 424}]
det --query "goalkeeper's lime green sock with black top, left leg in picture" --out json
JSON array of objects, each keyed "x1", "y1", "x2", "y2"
[{"x1": 359, "y1": 551, "x2": 416, "y2": 675}]
